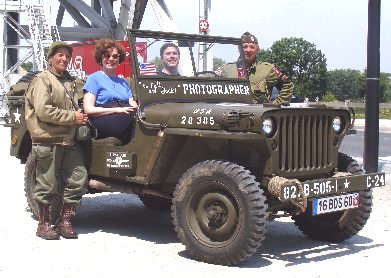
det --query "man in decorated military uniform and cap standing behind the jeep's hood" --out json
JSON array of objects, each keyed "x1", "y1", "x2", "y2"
[{"x1": 221, "y1": 32, "x2": 293, "y2": 105}]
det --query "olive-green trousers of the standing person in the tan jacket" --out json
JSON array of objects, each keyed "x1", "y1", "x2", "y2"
[{"x1": 32, "y1": 142, "x2": 88, "y2": 205}]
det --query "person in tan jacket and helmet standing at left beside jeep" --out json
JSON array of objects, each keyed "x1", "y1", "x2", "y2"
[{"x1": 25, "y1": 41, "x2": 88, "y2": 240}]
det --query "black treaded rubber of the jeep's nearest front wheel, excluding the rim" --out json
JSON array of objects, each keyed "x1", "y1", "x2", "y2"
[{"x1": 172, "y1": 160, "x2": 267, "y2": 265}]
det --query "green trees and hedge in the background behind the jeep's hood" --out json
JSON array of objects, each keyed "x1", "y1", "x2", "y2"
[{"x1": 257, "y1": 38, "x2": 391, "y2": 102}]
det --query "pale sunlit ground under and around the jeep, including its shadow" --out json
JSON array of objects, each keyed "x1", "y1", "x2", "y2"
[{"x1": 0, "y1": 127, "x2": 391, "y2": 278}]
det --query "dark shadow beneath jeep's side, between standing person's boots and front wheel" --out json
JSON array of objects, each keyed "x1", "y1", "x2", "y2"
[{"x1": 74, "y1": 193, "x2": 178, "y2": 244}]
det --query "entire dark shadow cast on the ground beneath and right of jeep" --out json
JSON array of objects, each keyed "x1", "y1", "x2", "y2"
[{"x1": 66, "y1": 193, "x2": 382, "y2": 268}]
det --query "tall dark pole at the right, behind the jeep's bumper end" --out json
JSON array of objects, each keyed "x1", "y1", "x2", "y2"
[{"x1": 364, "y1": 0, "x2": 381, "y2": 173}]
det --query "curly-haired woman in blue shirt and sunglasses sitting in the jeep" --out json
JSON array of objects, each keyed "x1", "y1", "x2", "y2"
[{"x1": 83, "y1": 39, "x2": 138, "y2": 144}]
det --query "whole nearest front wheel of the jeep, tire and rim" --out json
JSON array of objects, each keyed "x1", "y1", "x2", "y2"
[{"x1": 172, "y1": 160, "x2": 267, "y2": 265}]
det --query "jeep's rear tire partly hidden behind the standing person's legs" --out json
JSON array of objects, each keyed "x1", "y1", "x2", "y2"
[{"x1": 24, "y1": 153, "x2": 63, "y2": 224}]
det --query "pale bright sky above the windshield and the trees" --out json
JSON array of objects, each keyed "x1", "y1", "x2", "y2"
[{"x1": 141, "y1": 0, "x2": 391, "y2": 73}]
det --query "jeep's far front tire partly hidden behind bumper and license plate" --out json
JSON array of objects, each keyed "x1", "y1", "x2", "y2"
[{"x1": 292, "y1": 153, "x2": 372, "y2": 242}]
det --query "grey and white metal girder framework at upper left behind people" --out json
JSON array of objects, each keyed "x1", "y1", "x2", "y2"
[{"x1": 0, "y1": 0, "x2": 177, "y2": 77}]
